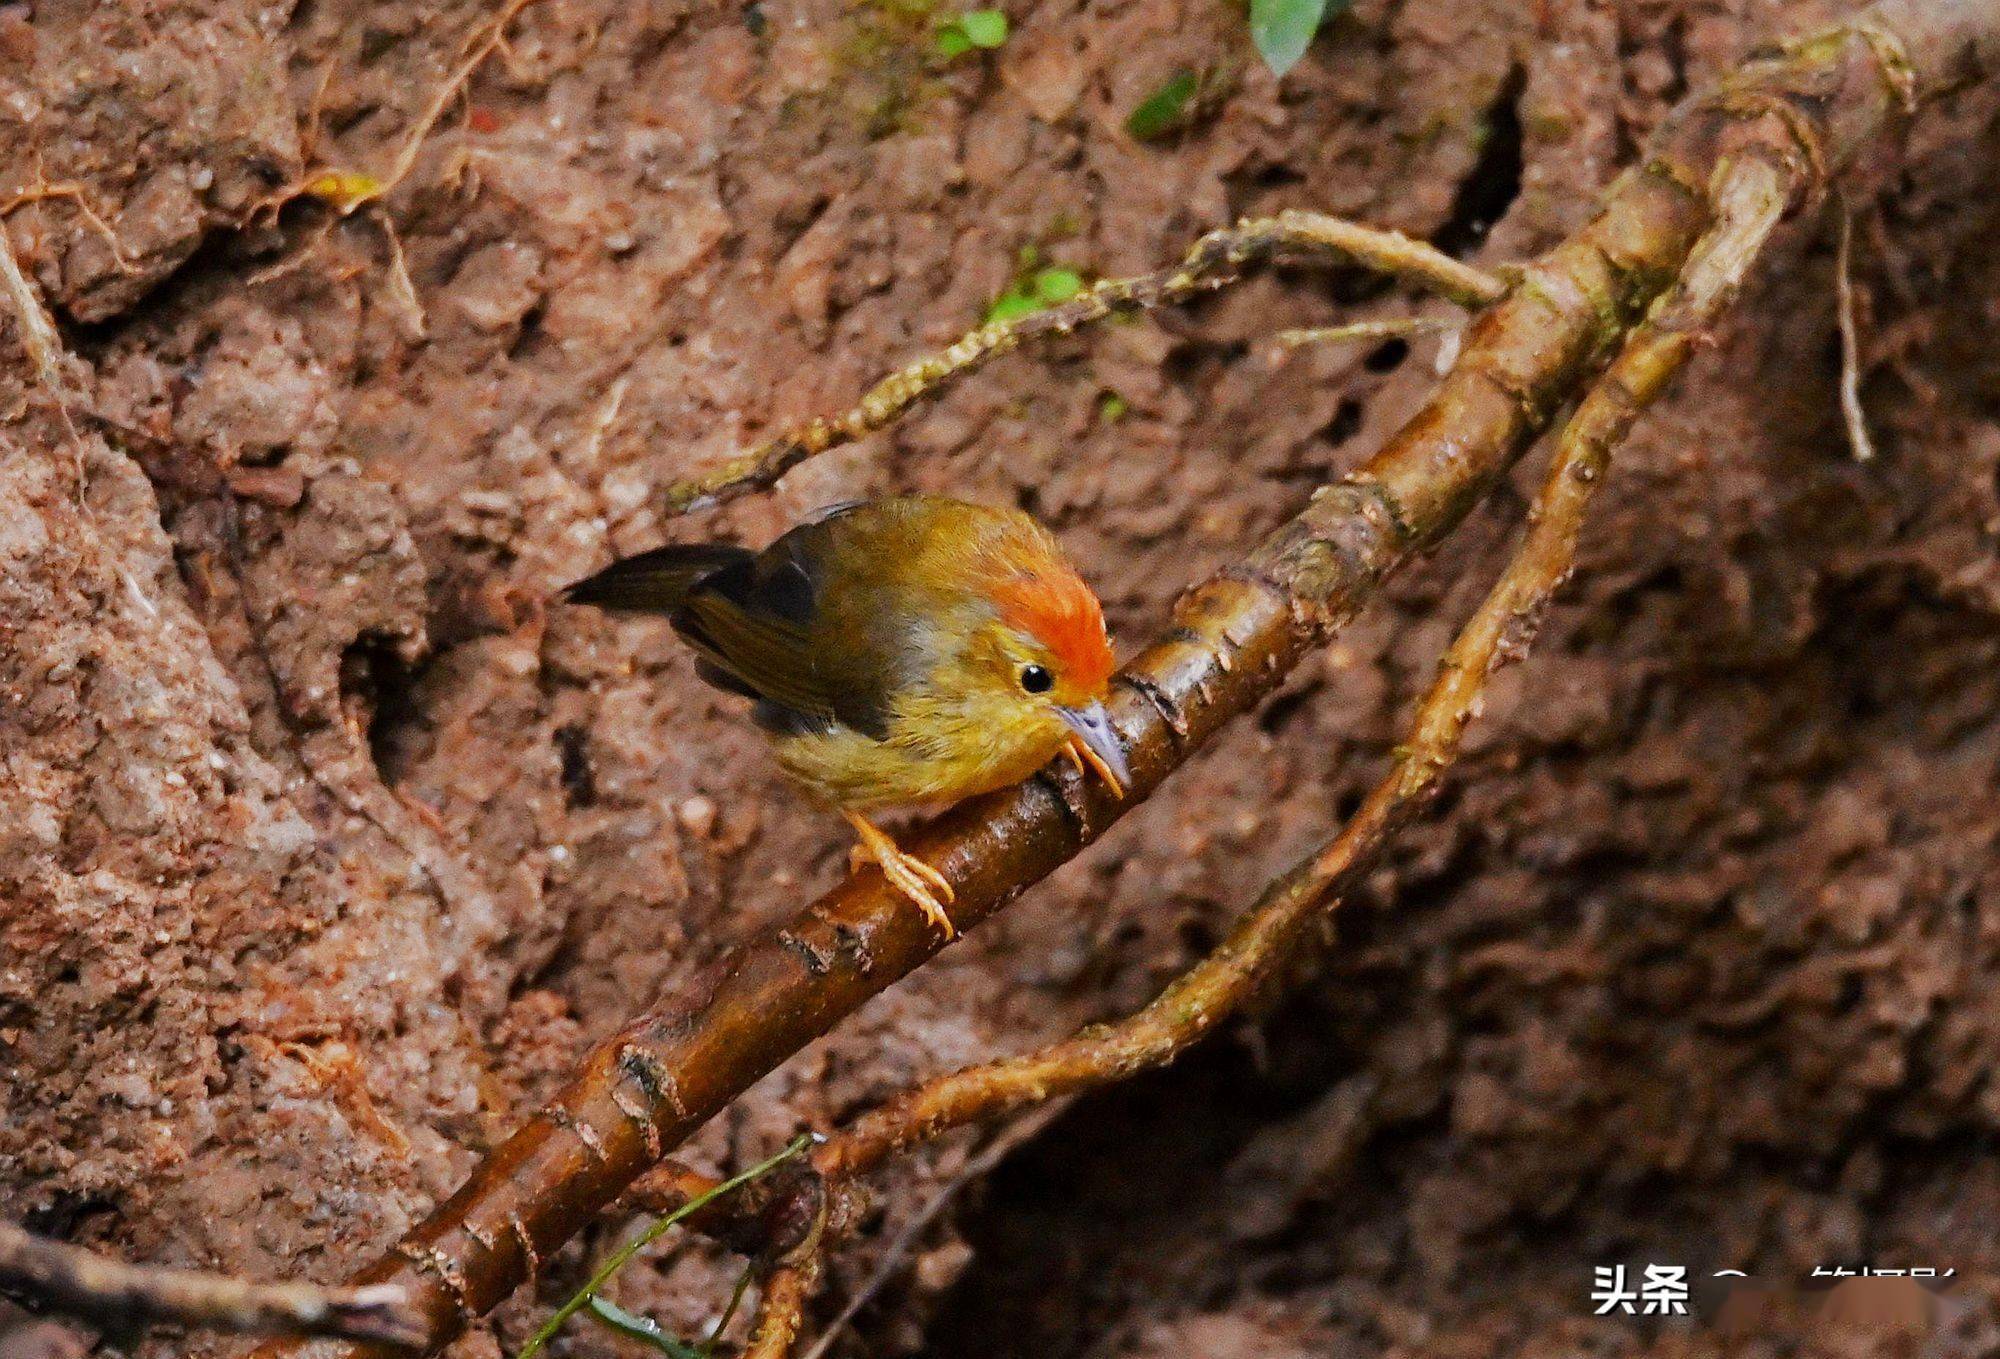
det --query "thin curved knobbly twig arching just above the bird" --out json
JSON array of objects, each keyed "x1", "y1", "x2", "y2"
[{"x1": 666, "y1": 210, "x2": 1506, "y2": 514}]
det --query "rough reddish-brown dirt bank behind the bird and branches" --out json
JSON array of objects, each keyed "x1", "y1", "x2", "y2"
[{"x1": 0, "y1": 0, "x2": 2000, "y2": 1359}]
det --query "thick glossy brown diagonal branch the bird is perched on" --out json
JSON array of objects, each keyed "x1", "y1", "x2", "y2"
[{"x1": 258, "y1": 0, "x2": 2000, "y2": 1353}]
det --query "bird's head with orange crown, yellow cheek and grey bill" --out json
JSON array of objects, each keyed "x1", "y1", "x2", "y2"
[{"x1": 920, "y1": 556, "x2": 1132, "y2": 793}]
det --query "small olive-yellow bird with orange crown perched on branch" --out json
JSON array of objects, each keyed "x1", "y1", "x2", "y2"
[{"x1": 564, "y1": 496, "x2": 1132, "y2": 937}]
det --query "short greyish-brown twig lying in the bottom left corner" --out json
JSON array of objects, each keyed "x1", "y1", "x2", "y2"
[{"x1": 0, "y1": 1223, "x2": 426, "y2": 1347}]
